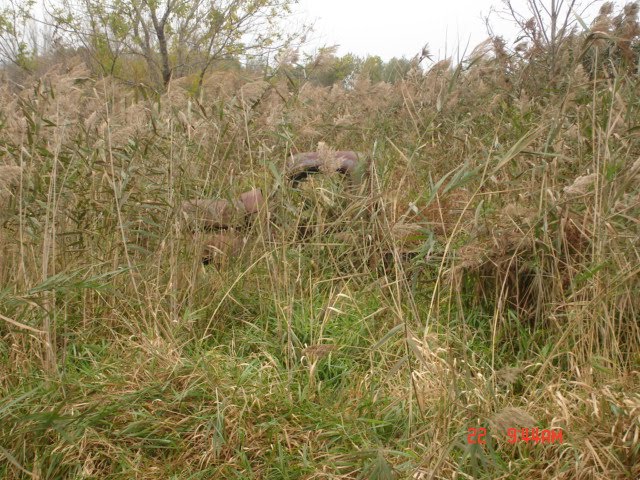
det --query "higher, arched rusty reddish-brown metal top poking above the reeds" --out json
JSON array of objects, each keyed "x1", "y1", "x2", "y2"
[{"x1": 287, "y1": 150, "x2": 365, "y2": 186}]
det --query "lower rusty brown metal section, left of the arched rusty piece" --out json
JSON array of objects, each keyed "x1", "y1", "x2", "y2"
[{"x1": 181, "y1": 188, "x2": 264, "y2": 230}]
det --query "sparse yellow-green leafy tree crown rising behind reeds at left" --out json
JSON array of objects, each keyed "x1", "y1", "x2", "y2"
[{"x1": 56, "y1": 0, "x2": 295, "y2": 87}]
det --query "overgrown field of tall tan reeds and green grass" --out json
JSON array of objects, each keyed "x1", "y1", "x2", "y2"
[{"x1": 0, "y1": 9, "x2": 640, "y2": 479}]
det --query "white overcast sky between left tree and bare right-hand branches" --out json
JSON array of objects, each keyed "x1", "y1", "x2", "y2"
[{"x1": 298, "y1": 0, "x2": 604, "y2": 60}]
